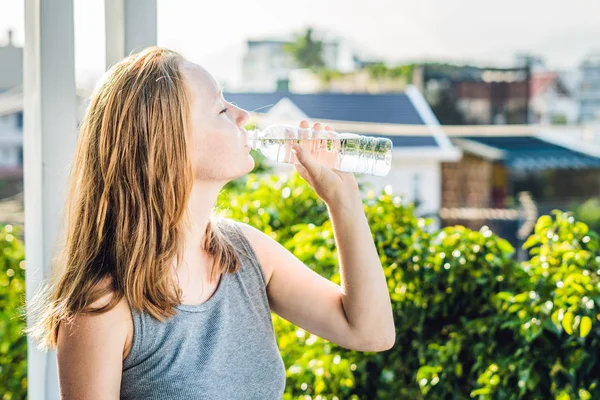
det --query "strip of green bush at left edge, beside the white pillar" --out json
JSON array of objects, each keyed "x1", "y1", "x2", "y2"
[{"x1": 0, "y1": 225, "x2": 27, "y2": 400}]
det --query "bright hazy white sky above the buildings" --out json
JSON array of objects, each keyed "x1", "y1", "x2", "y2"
[{"x1": 0, "y1": 0, "x2": 600, "y2": 88}]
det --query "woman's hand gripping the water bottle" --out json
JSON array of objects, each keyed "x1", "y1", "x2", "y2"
[{"x1": 292, "y1": 121, "x2": 360, "y2": 206}]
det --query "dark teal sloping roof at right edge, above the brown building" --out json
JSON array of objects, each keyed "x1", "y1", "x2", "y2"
[{"x1": 455, "y1": 136, "x2": 600, "y2": 171}]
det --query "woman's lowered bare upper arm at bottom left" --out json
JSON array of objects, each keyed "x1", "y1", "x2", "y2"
[{"x1": 57, "y1": 299, "x2": 133, "y2": 400}]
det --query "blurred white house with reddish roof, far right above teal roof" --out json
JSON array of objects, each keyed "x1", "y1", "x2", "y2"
[{"x1": 529, "y1": 71, "x2": 579, "y2": 125}]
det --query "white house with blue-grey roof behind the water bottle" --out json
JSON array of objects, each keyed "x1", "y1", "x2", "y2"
[{"x1": 225, "y1": 87, "x2": 461, "y2": 225}]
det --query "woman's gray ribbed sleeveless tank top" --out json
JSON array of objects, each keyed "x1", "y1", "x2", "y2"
[{"x1": 121, "y1": 221, "x2": 285, "y2": 400}]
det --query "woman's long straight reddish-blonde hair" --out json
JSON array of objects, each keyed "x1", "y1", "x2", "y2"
[{"x1": 26, "y1": 47, "x2": 239, "y2": 349}]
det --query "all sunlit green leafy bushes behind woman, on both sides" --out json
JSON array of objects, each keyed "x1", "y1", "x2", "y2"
[{"x1": 0, "y1": 167, "x2": 600, "y2": 400}]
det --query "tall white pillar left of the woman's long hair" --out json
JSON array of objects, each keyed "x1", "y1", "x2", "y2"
[{"x1": 23, "y1": 0, "x2": 77, "y2": 400}]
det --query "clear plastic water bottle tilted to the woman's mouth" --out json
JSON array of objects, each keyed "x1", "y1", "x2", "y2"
[{"x1": 248, "y1": 125, "x2": 393, "y2": 176}]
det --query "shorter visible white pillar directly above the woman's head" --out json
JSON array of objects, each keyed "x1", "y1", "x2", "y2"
[{"x1": 104, "y1": 0, "x2": 157, "y2": 69}]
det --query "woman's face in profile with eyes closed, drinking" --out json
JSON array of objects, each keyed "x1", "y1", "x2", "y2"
[{"x1": 181, "y1": 61, "x2": 254, "y2": 183}]
